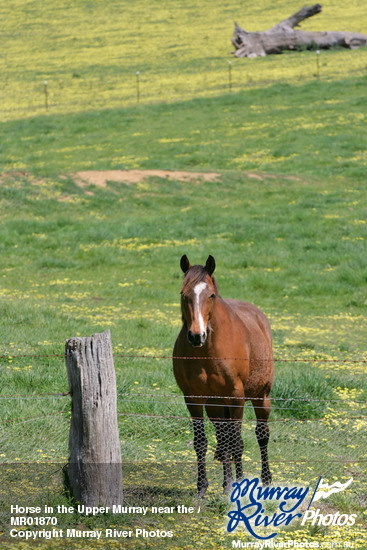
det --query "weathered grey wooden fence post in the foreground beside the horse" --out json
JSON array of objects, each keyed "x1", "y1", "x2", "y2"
[{"x1": 65, "y1": 330, "x2": 123, "y2": 506}]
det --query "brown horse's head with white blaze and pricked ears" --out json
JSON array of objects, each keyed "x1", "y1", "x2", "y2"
[{"x1": 180, "y1": 255, "x2": 218, "y2": 347}]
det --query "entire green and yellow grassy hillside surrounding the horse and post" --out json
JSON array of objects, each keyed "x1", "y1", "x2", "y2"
[{"x1": 0, "y1": 0, "x2": 367, "y2": 549}]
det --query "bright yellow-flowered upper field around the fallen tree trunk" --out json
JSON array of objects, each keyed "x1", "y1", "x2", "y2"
[{"x1": 0, "y1": 0, "x2": 367, "y2": 119}]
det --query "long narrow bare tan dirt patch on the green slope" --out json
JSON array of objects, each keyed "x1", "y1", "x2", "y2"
[{"x1": 73, "y1": 170, "x2": 220, "y2": 187}]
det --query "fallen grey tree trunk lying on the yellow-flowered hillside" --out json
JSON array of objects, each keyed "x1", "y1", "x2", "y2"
[{"x1": 232, "y1": 4, "x2": 367, "y2": 57}]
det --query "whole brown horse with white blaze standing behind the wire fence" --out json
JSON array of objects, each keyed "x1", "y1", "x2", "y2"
[{"x1": 173, "y1": 255, "x2": 274, "y2": 496}]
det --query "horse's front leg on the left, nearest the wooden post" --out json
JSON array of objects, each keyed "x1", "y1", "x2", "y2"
[{"x1": 186, "y1": 401, "x2": 209, "y2": 498}]
